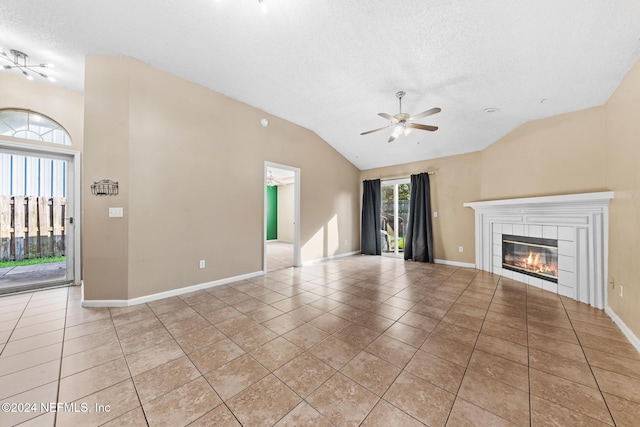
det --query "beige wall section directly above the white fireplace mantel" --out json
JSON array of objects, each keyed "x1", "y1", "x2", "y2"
[{"x1": 480, "y1": 107, "x2": 606, "y2": 200}]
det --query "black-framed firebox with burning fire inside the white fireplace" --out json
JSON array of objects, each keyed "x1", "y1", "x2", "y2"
[{"x1": 502, "y1": 234, "x2": 558, "y2": 283}]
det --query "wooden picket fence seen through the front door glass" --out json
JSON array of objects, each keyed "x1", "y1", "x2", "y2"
[{"x1": 0, "y1": 195, "x2": 66, "y2": 261}]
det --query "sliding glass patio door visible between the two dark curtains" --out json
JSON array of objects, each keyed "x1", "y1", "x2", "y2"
[{"x1": 380, "y1": 179, "x2": 411, "y2": 256}]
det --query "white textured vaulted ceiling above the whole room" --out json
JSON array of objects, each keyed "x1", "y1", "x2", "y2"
[{"x1": 0, "y1": 0, "x2": 640, "y2": 169}]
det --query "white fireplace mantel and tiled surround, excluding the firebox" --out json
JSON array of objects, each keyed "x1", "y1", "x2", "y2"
[{"x1": 464, "y1": 191, "x2": 614, "y2": 309}]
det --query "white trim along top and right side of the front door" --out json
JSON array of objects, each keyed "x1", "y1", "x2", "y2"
[{"x1": 0, "y1": 138, "x2": 82, "y2": 285}]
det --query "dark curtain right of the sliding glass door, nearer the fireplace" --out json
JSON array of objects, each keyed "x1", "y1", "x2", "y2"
[{"x1": 404, "y1": 173, "x2": 433, "y2": 262}]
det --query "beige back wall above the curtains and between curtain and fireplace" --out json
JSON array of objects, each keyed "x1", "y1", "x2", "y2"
[{"x1": 360, "y1": 150, "x2": 480, "y2": 264}]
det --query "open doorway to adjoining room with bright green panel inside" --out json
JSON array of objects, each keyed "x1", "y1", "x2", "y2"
[{"x1": 263, "y1": 162, "x2": 301, "y2": 272}]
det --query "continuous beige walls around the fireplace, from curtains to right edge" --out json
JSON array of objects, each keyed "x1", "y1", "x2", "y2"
[{"x1": 361, "y1": 61, "x2": 640, "y2": 342}]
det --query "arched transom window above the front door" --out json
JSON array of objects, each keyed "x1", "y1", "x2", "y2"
[{"x1": 0, "y1": 109, "x2": 71, "y2": 145}]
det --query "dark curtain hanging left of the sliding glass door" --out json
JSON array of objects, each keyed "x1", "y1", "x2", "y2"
[{"x1": 360, "y1": 179, "x2": 382, "y2": 255}]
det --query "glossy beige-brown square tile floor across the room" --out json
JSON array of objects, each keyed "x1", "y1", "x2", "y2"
[{"x1": 0, "y1": 256, "x2": 640, "y2": 426}]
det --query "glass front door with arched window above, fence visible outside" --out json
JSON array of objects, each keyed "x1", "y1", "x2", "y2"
[{"x1": 0, "y1": 110, "x2": 80, "y2": 294}]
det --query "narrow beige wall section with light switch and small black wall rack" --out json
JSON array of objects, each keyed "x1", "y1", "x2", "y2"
[{"x1": 82, "y1": 60, "x2": 131, "y2": 300}]
